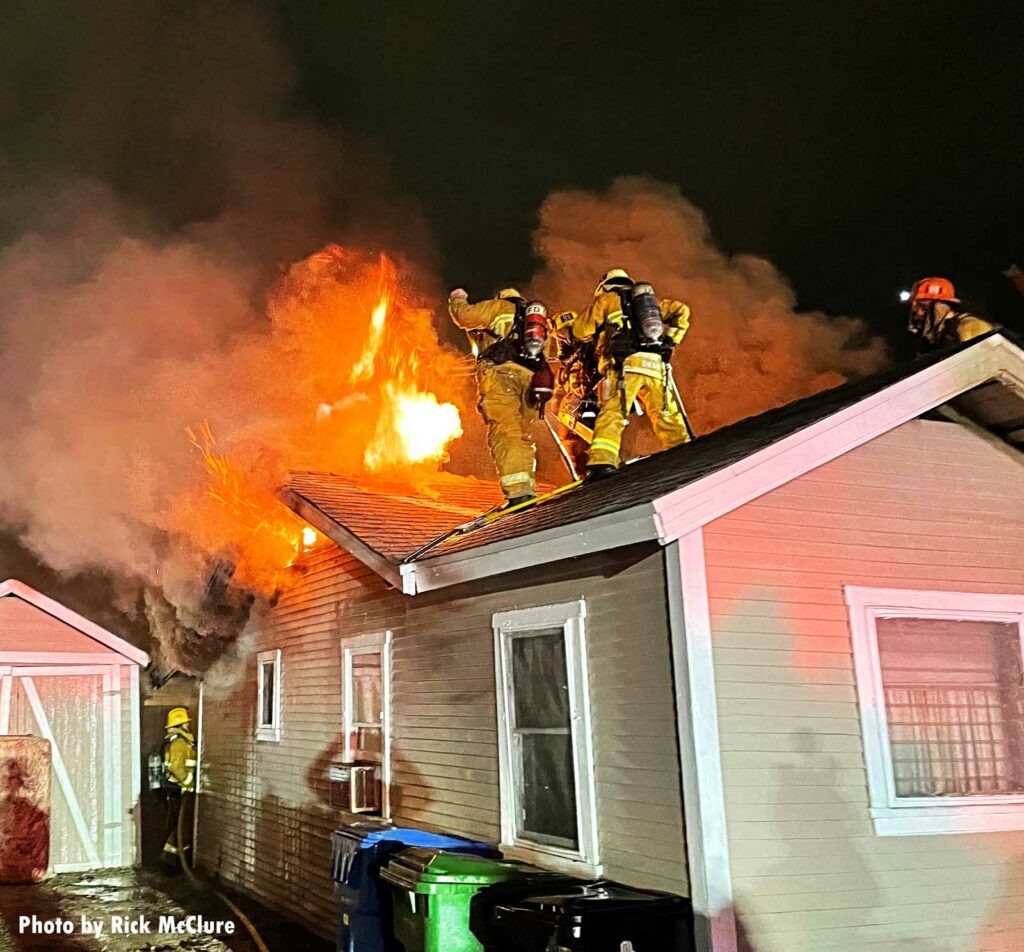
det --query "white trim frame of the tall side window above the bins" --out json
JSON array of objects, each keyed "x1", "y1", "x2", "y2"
[{"x1": 492, "y1": 599, "x2": 601, "y2": 874}]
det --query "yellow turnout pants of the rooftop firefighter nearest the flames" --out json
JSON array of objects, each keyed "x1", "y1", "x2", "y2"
[{"x1": 477, "y1": 360, "x2": 538, "y2": 499}]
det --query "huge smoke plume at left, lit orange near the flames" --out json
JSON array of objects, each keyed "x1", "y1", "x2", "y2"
[{"x1": 0, "y1": 0, "x2": 460, "y2": 670}]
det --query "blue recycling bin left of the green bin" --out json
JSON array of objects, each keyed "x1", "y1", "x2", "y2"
[{"x1": 331, "y1": 824, "x2": 501, "y2": 952}]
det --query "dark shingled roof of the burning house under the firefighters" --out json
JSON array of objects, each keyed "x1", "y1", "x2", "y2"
[{"x1": 286, "y1": 332, "x2": 1024, "y2": 591}]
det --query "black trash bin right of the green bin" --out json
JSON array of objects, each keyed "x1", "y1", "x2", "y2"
[{"x1": 470, "y1": 879, "x2": 694, "y2": 952}]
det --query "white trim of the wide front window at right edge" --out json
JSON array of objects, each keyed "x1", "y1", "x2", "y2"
[{"x1": 845, "y1": 586, "x2": 1024, "y2": 836}]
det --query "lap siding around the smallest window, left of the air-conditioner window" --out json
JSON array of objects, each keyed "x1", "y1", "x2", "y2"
[{"x1": 198, "y1": 550, "x2": 378, "y2": 936}]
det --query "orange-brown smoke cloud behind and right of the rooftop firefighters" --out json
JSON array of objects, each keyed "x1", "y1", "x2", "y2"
[{"x1": 531, "y1": 178, "x2": 886, "y2": 438}]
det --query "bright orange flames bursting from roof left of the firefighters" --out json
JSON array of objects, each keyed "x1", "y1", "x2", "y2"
[{"x1": 180, "y1": 246, "x2": 472, "y2": 594}]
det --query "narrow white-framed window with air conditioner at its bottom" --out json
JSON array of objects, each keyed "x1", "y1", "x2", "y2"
[{"x1": 341, "y1": 632, "x2": 391, "y2": 816}]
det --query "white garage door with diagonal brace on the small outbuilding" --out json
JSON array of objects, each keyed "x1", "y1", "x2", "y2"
[{"x1": 0, "y1": 665, "x2": 124, "y2": 872}]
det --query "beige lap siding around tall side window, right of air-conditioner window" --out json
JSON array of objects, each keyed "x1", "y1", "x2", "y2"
[{"x1": 392, "y1": 550, "x2": 688, "y2": 893}]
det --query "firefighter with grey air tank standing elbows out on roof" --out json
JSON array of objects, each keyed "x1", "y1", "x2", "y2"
[{"x1": 572, "y1": 268, "x2": 693, "y2": 477}]
